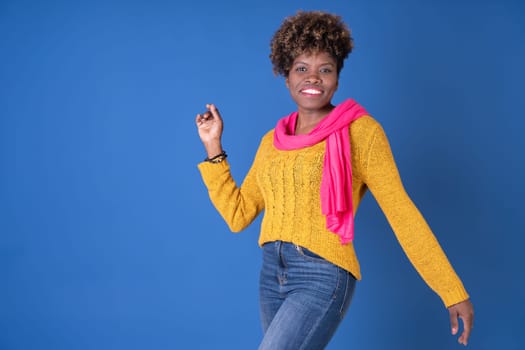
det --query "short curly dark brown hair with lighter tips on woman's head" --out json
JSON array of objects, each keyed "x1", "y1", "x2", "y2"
[{"x1": 270, "y1": 11, "x2": 354, "y2": 77}]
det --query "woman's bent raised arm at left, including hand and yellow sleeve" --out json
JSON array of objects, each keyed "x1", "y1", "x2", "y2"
[{"x1": 196, "y1": 104, "x2": 264, "y2": 232}]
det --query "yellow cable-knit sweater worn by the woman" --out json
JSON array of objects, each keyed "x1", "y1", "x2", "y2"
[{"x1": 198, "y1": 116, "x2": 468, "y2": 307}]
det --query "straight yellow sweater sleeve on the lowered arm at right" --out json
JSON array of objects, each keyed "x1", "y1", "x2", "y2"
[{"x1": 365, "y1": 124, "x2": 469, "y2": 307}]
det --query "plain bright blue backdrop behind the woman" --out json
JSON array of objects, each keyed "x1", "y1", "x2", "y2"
[{"x1": 0, "y1": 0, "x2": 525, "y2": 350}]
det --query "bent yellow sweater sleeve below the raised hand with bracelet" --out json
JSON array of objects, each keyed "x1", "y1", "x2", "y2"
[{"x1": 198, "y1": 140, "x2": 264, "y2": 232}]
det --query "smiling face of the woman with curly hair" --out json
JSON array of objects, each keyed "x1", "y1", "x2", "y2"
[{"x1": 286, "y1": 52, "x2": 339, "y2": 115}]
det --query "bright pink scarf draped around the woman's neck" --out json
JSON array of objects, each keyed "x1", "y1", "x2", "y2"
[{"x1": 273, "y1": 99, "x2": 368, "y2": 244}]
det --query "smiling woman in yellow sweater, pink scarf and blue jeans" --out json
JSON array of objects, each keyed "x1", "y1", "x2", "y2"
[{"x1": 196, "y1": 11, "x2": 473, "y2": 349}]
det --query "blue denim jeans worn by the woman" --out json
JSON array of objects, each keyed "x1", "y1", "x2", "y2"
[{"x1": 259, "y1": 241, "x2": 356, "y2": 350}]
